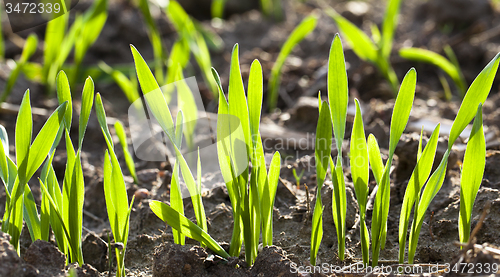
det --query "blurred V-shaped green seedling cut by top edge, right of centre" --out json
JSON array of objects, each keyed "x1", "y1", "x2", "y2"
[{"x1": 323, "y1": 0, "x2": 401, "y2": 95}]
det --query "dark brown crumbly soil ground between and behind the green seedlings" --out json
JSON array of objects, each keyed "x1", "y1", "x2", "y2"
[{"x1": 0, "y1": 0, "x2": 500, "y2": 276}]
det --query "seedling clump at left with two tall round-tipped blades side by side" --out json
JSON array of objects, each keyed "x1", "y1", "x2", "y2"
[{"x1": 33, "y1": 71, "x2": 94, "y2": 265}]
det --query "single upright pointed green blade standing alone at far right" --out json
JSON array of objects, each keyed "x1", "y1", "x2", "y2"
[{"x1": 458, "y1": 104, "x2": 486, "y2": 243}]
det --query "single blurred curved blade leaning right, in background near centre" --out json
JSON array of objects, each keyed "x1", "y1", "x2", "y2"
[{"x1": 267, "y1": 15, "x2": 318, "y2": 110}]
